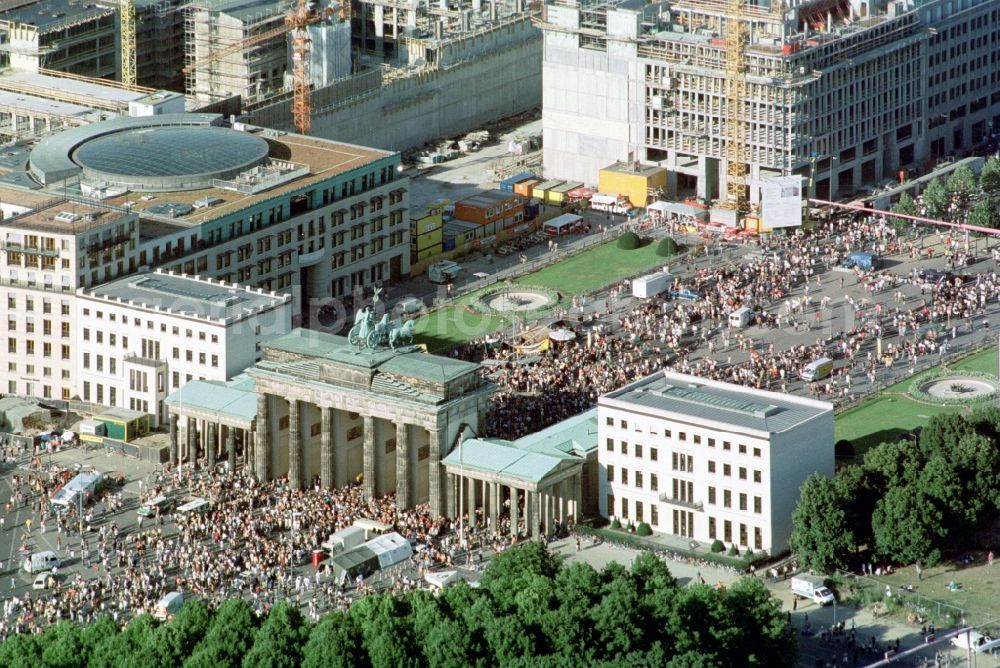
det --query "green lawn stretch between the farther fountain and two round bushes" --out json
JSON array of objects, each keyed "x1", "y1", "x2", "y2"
[{"x1": 516, "y1": 241, "x2": 668, "y2": 295}]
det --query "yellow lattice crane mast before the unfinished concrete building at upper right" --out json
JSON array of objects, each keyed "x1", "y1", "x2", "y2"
[{"x1": 723, "y1": 0, "x2": 749, "y2": 219}]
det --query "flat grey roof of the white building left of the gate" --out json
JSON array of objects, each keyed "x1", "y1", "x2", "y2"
[{"x1": 79, "y1": 271, "x2": 291, "y2": 320}]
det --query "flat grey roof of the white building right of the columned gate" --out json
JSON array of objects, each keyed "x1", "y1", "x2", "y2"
[{"x1": 600, "y1": 371, "x2": 833, "y2": 434}]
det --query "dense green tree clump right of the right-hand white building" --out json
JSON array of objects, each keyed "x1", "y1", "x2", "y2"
[{"x1": 791, "y1": 407, "x2": 1000, "y2": 572}]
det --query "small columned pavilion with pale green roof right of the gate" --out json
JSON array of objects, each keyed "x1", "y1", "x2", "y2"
[{"x1": 444, "y1": 409, "x2": 598, "y2": 538}]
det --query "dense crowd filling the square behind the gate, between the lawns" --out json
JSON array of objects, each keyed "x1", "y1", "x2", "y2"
[{"x1": 452, "y1": 216, "x2": 1000, "y2": 438}]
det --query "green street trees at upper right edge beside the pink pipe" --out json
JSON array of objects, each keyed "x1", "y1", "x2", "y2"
[{"x1": 892, "y1": 157, "x2": 1000, "y2": 228}]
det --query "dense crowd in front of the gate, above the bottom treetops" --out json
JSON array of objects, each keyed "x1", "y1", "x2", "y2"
[{"x1": 0, "y1": 462, "x2": 523, "y2": 640}]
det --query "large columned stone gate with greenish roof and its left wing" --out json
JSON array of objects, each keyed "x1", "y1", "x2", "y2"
[{"x1": 166, "y1": 329, "x2": 493, "y2": 516}]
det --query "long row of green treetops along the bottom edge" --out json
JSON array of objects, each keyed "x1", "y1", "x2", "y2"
[{"x1": 0, "y1": 543, "x2": 798, "y2": 668}]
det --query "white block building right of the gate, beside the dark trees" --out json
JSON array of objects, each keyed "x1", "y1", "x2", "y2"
[{"x1": 598, "y1": 372, "x2": 834, "y2": 554}]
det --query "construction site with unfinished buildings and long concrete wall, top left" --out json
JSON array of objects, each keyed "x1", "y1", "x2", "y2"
[{"x1": 0, "y1": 0, "x2": 541, "y2": 150}]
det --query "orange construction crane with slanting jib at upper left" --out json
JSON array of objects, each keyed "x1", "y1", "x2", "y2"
[{"x1": 181, "y1": 0, "x2": 338, "y2": 134}]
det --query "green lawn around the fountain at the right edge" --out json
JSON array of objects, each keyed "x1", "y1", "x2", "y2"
[{"x1": 834, "y1": 347, "x2": 997, "y2": 455}]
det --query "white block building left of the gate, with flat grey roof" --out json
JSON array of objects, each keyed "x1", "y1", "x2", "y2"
[{"x1": 75, "y1": 271, "x2": 292, "y2": 424}]
